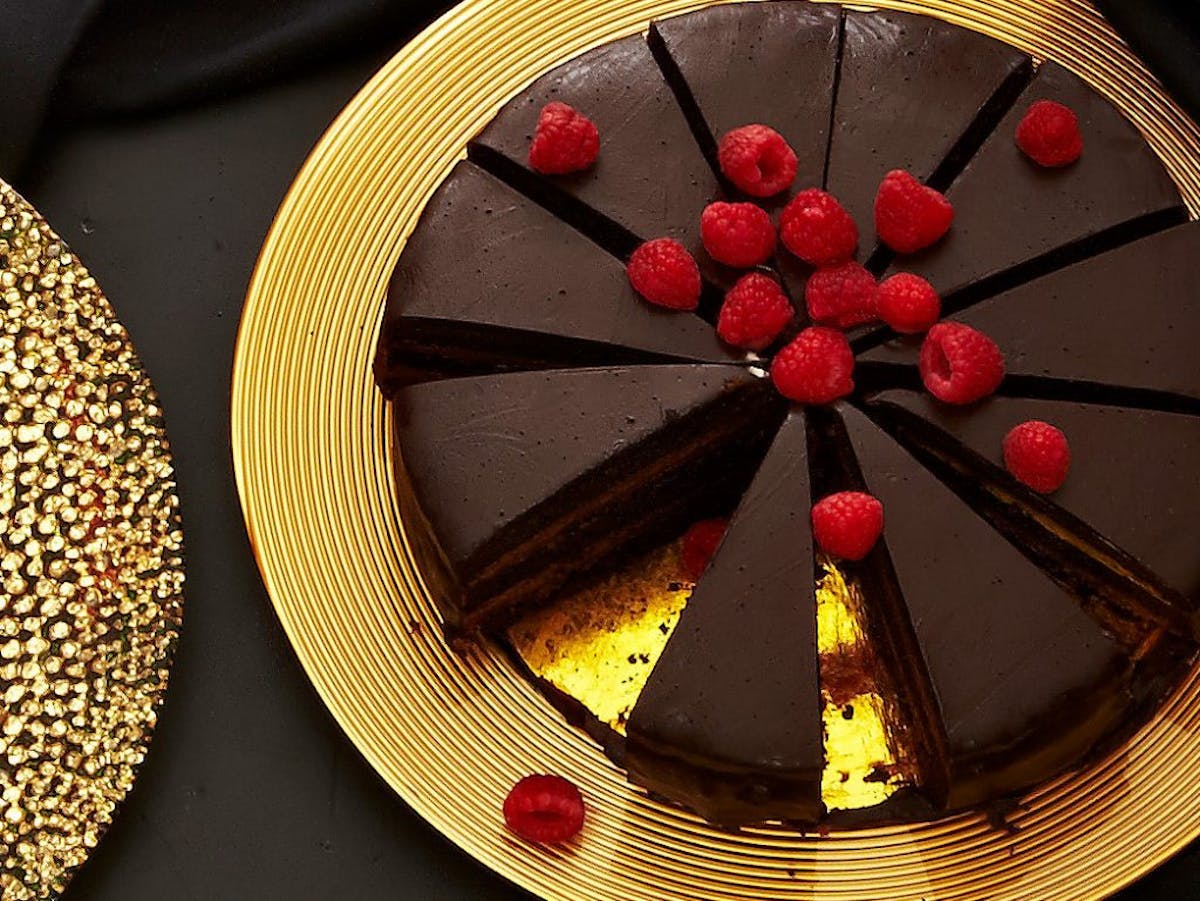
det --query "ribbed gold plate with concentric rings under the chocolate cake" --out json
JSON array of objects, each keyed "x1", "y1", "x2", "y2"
[{"x1": 233, "y1": 0, "x2": 1200, "y2": 901}]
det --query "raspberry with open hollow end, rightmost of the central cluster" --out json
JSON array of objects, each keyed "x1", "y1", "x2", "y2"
[{"x1": 920, "y1": 323, "x2": 1004, "y2": 403}]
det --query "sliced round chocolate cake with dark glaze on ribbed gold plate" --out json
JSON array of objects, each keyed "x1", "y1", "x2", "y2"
[{"x1": 376, "y1": 0, "x2": 1200, "y2": 827}]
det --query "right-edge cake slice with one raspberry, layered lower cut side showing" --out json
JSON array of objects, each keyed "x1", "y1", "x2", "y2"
[{"x1": 871, "y1": 390, "x2": 1200, "y2": 625}]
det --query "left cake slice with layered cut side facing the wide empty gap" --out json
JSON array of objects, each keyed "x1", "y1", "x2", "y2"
[{"x1": 392, "y1": 364, "x2": 782, "y2": 632}]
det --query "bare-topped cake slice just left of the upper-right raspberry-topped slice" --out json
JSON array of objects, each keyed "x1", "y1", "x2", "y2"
[{"x1": 826, "y1": 10, "x2": 1032, "y2": 259}]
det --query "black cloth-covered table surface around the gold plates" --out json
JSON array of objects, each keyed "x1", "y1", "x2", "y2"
[{"x1": 0, "y1": 0, "x2": 1200, "y2": 901}]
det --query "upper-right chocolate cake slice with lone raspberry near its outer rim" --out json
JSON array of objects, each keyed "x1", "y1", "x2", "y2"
[{"x1": 893, "y1": 62, "x2": 1186, "y2": 298}]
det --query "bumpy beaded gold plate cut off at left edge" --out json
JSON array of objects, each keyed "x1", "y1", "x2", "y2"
[{"x1": 0, "y1": 184, "x2": 184, "y2": 901}]
